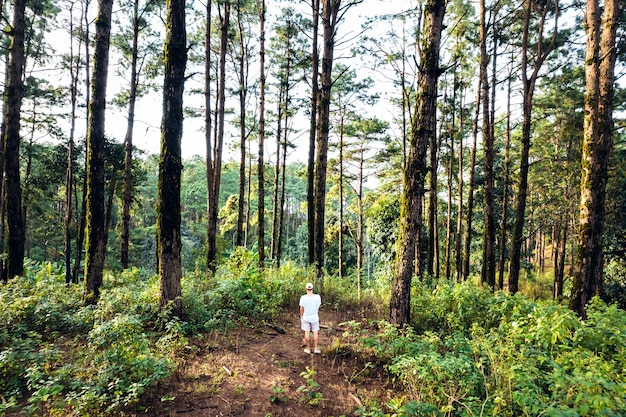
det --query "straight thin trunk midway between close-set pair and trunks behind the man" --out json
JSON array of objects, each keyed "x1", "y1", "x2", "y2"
[{"x1": 257, "y1": 0, "x2": 265, "y2": 267}]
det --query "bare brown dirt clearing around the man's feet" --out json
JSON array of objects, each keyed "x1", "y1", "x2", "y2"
[{"x1": 125, "y1": 311, "x2": 392, "y2": 417}]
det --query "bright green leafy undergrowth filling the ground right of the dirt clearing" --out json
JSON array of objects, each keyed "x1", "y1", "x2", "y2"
[{"x1": 346, "y1": 283, "x2": 626, "y2": 416}]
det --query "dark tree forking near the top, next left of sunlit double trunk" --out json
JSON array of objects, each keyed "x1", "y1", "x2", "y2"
[{"x1": 509, "y1": 0, "x2": 559, "y2": 294}]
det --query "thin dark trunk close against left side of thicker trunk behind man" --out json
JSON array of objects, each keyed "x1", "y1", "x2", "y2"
[{"x1": 306, "y1": 0, "x2": 320, "y2": 264}]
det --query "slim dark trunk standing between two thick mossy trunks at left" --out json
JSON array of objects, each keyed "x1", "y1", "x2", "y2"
[{"x1": 120, "y1": 0, "x2": 139, "y2": 269}]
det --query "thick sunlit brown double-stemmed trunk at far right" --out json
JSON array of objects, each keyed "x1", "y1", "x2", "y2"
[{"x1": 569, "y1": 0, "x2": 620, "y2": 317}]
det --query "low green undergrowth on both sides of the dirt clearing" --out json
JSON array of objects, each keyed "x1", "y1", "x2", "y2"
[{"x1": 0, "y1": 252, "x2": 626, "y2": 417}]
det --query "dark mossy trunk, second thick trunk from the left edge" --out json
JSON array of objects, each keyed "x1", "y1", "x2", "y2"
[{"x1": 84, "y1": 0, "x2": 113, "y2": 304}]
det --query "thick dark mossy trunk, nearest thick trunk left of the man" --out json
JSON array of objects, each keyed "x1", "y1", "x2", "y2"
[{"x1": 157, "y1": 0, "x2": 187, "y2": 317}]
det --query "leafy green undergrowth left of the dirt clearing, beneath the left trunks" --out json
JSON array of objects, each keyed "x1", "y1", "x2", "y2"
[{"x1": 0, "y1": 263, "x2": 177, "y2": 415}]
